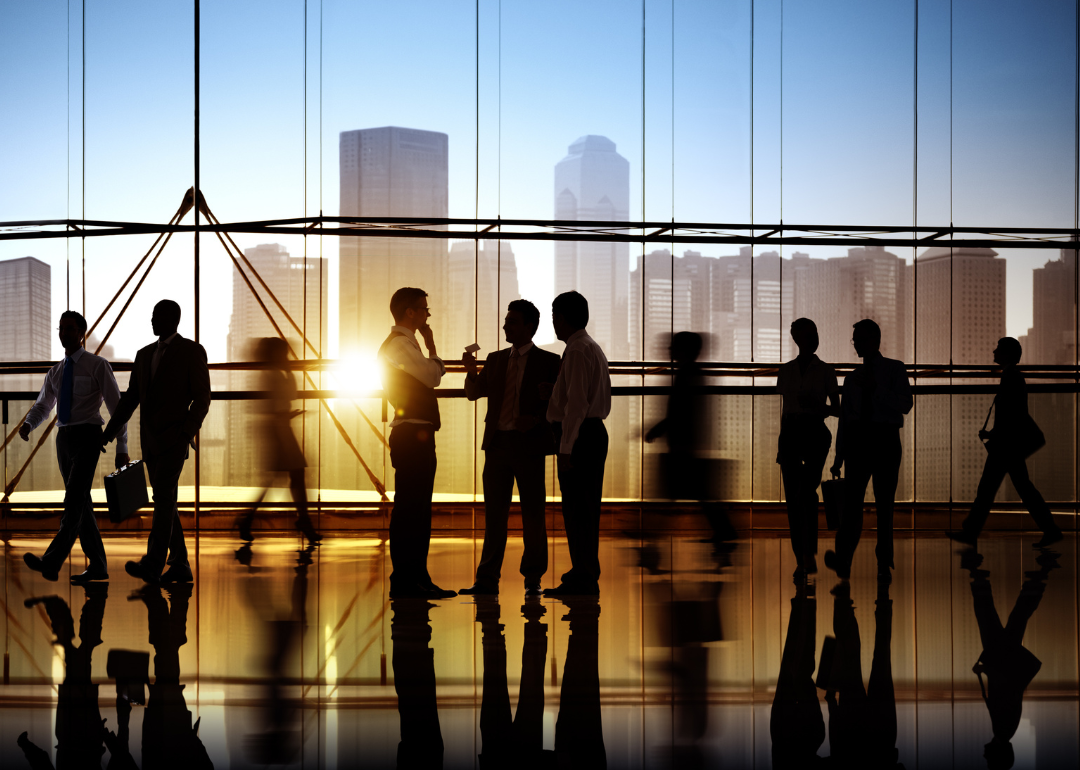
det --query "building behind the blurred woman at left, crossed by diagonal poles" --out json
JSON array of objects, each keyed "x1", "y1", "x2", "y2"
[{"x1": 225, "y1": 243, "x2": 327, "y2": 486}]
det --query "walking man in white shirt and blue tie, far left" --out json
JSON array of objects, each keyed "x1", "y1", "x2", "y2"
[{"x1": 18, "y1": 310, "x2": 129, "y2": 585}]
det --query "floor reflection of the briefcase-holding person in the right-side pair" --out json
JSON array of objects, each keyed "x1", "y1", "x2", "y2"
[{"x1": 825, "y1": 580, "x2": 900, "y2": 770}]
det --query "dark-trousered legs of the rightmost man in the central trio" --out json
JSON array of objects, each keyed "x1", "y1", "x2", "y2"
[{"x1": 558, "y1": 418, "x2": 608, "y2": 593}]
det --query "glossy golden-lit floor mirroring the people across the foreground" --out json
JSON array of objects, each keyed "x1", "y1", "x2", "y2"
[{"x1": 0, "y1": 535, "x2": 1080, "y2": 770}]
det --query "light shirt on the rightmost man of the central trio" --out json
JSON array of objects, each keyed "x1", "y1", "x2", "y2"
[{"x1": 548, "y1": 329, "x2": 611, "y2": 455}]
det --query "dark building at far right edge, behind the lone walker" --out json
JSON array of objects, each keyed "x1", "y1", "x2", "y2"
[{"x1": 1021, "y1": 249, "x2": 1077, "y2": 500}]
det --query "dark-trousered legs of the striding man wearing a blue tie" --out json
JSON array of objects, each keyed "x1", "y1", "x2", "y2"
[{"x1": 41, "y1": 425, "x2": 109, "y2": 578}]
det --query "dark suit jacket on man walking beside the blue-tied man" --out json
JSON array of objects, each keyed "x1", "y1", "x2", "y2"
[{"x1": 105, "y1": 335, "x2": 210, "y2": 455}]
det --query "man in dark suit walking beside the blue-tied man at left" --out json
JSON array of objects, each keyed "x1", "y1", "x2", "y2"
[{"x1": 102, "y1": 299, "x2": 210, "y2": 583}]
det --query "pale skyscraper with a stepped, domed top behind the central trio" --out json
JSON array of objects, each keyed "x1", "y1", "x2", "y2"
[{"x1": 554, "y1": 135, "x2": 639, "y2": 497}]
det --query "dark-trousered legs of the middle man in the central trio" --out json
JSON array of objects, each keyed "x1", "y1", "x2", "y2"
[{"x1": 475, "y1": 431, "x2": 548, "y2": 593}]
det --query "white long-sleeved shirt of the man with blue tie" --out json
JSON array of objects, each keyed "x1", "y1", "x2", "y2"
[{"x1": 24, "y1": 348, "x2": 127, "y2": 455}]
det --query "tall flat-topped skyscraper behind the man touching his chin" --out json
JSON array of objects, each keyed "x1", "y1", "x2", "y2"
[{"x1": 338, "y1": 126, "x2": 450, "y2": 357}]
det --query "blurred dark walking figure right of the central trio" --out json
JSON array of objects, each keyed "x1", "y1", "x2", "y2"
[{"x1": 642, "y1": 332, "x2": 735, "y2": 567}]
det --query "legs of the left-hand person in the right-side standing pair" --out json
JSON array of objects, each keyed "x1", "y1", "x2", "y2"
[{"x1": 777, "y1": 415, "x2": 833, "y2": 572}]
